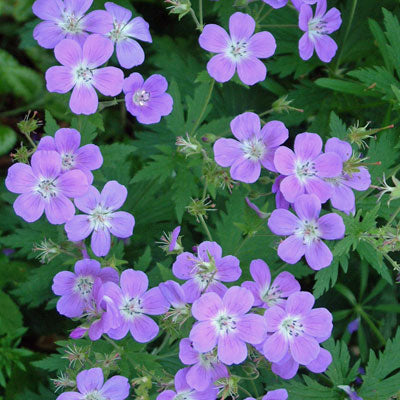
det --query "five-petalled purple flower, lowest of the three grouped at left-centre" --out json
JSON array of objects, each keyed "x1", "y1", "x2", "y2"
[{"x1": 65, "y1": 181, "x2": 135, "y2": 257}]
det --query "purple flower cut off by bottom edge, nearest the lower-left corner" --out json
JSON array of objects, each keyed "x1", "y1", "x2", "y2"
[{"x1": 57, "y1": 368, "x2": 130, "y2": 400}]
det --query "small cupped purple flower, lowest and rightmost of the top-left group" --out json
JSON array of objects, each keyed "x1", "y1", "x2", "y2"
[{"x1": 123, "y1": 72, "x2": 173, "y2": 124}]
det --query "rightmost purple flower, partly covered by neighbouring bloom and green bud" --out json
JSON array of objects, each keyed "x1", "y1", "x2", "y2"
[{"x1": 325, "y1": 138, "x2": 371, "y2": 214}]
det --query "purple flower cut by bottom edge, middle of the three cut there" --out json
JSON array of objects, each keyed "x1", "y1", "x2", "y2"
[{"x1": 156, "y1": 368, "x2": 218, "y2": 400}]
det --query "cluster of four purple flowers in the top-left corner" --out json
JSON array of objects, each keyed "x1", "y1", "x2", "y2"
[{"x1": 33, "y1": 0, "x2": 173, "y2": 120}]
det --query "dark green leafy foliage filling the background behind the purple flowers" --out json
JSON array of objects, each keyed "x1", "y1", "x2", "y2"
[{"x1": 0, "y1": 0, "x2": 400, "y2": 400}]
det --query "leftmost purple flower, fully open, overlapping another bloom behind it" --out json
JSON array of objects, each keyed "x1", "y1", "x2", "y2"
[{"x1": 5, "y1": 150, "x2": 89, "y2": 224}]
